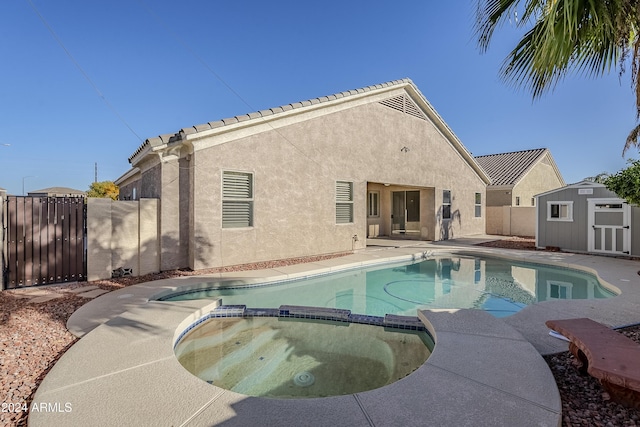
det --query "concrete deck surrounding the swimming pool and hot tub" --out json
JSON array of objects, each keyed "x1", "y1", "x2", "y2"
[{"x1": 29, "y1": 240, "x2": 640, "y2": 426}]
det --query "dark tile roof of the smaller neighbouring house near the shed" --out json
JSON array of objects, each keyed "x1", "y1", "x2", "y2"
[{"x1": 476, "y1": 148, "x2": 564, "y2": 187}]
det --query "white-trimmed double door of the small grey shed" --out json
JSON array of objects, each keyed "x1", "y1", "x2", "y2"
[{"x1": 588, "y1": 199, "x2": 631, "y2": 254}]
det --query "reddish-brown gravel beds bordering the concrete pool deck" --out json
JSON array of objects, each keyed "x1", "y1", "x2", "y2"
[{"x1": 0, "y1": 244, "x2": 640, "y2": 426}]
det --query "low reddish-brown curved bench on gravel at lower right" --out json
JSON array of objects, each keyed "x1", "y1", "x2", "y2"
[{"x1": 545, "y1": 318, "x2": 640, "y2": 409}]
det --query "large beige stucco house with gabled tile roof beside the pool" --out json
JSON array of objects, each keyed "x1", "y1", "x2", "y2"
[{"x1": 116, "y1": 79, "x2": 489, "y2": 270}]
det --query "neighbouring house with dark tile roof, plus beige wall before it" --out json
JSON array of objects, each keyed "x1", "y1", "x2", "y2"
[{"x1": 475, "y1": 148, "x2": 565, "y2": 236}]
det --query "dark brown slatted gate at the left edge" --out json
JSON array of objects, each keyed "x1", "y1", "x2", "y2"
[{"x1": 3, "y1": 196, "x2": 87, "y2": 289}]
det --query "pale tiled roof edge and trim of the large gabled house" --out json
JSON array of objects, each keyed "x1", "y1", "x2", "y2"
[{"x1": 124, "y1": 78, "x2": 489, "y2": 183}]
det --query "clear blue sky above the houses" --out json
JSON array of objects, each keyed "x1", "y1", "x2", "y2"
[{"x1": 0, "y1": 0, "x2": 638, "y2": 194}]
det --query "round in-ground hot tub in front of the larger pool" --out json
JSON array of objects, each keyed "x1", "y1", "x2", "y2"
[{"x1": 175, "y1": 309, "x2": 433, "y2": 398}]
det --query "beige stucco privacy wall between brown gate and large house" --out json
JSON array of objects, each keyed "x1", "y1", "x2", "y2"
[{"x1": 87, "y1": 198, "x2": 160, "y2": 281}]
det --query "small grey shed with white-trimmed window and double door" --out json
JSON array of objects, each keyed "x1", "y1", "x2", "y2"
[{"x1": 536, "y1": 181, "x2": 640, "y2": 256}]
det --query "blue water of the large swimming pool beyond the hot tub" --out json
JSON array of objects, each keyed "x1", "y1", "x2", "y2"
[{"x1": 162, "y1": 256, "x2": 614, "y2": 317}]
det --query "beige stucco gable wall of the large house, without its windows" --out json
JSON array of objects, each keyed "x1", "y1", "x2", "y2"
[{"x1": 182, "y1": 98, "x2": 485, "y2": 269}]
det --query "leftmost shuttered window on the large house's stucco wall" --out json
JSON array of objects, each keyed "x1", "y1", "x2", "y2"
[{"x1": 222, "y1": 171, "x2": 253, "y2": 228}]
